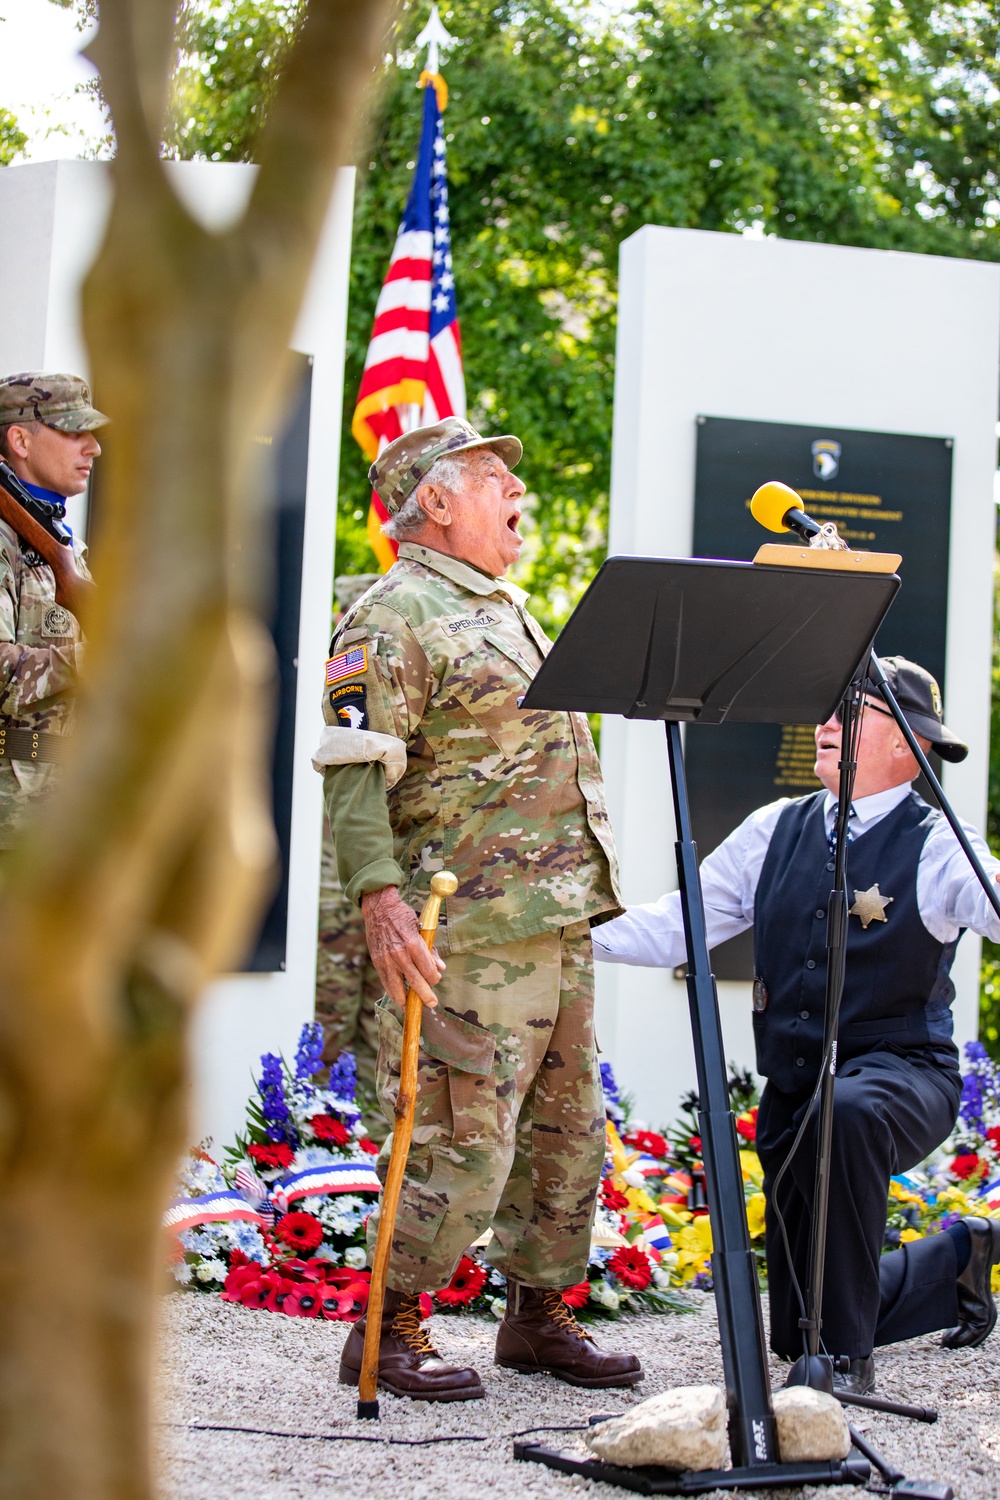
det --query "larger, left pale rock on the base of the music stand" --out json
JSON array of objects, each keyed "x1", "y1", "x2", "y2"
[{"x1": 585, "y1": 1386, "x2": 729, "y2": 1472}]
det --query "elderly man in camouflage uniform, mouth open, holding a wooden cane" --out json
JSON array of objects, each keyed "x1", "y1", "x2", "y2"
[{"x1": 315, "y1": 417, "x2": 642, "y2": 1401}]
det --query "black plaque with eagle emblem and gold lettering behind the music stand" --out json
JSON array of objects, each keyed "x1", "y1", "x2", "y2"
[{"x1": 685, "y1": 417, "x2": 952, "y2": 980}]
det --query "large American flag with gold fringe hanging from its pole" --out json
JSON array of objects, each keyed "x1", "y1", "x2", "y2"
[{"x1": 351, "y1": 74, "x2": 465, "y2": 572}]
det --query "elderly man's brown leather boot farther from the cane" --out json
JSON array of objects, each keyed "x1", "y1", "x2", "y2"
[{"x1": 495, "y1": 1281, "x2": 643, "y2": 1391}]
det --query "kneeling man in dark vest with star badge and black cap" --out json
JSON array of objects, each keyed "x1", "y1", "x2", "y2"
[{"x1": 592, "y1": 657, "x2": 1000, "y2": 1394}]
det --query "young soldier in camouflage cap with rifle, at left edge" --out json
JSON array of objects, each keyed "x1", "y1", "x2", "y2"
[{"x1": 0, "y1": 371, "x2": 108, "y2": 851}]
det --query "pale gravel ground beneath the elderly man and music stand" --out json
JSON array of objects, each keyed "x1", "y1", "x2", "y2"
[{"x1": 157, "y1": 1292, "x2": 1000, "y2": 1500}]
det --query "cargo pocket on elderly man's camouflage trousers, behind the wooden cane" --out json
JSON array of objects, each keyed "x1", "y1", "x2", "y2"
[{"x1": 378, "y1": 998, "x2": 496, "y2": 1151}]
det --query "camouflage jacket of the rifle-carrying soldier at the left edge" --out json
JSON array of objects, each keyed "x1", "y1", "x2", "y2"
[{"x1": 0, "y1": 521, "x2": 90, "y2": 849}]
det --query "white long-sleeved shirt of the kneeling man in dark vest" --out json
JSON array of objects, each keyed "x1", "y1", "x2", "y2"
[{"x1": 591, "y1": 782, "x2": 1000, "y2": 969}]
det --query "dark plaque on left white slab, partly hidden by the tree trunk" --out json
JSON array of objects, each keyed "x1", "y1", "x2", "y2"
[{"x1": 244, "y1": 354, "x2": 312, "y2": 974}]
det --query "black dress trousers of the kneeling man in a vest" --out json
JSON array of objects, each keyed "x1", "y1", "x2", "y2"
[{"x1": 757, "y1": 1049, "x2": 961, "y2": 1359}]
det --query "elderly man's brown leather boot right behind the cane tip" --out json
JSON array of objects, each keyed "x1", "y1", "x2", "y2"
[{"x1": 340, "y1": 1287, "x2": 486, "y2": 1401}]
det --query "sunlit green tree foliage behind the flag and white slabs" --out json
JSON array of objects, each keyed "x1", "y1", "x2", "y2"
[{"x1": 168, "y1": 0, "x2": 1000, "y2": 627}]
